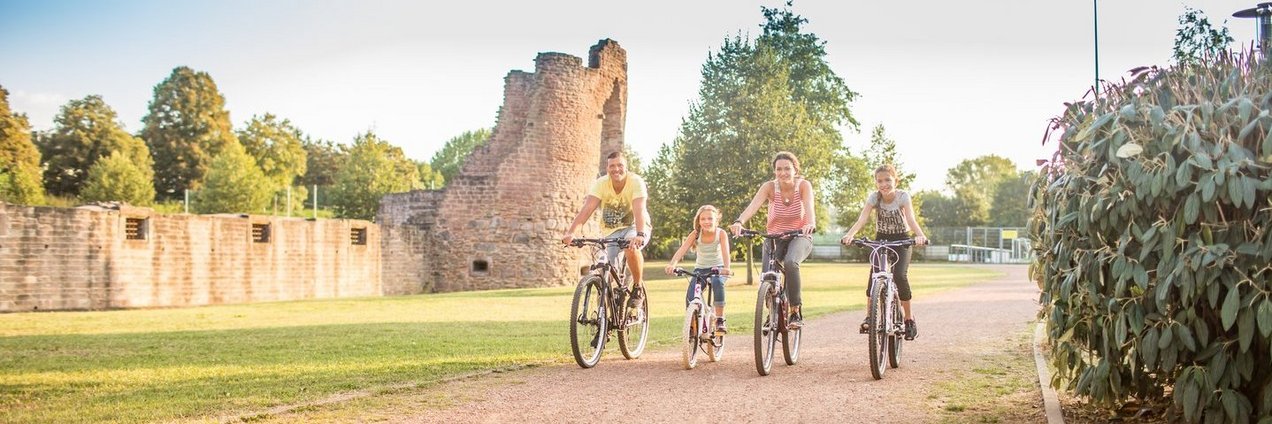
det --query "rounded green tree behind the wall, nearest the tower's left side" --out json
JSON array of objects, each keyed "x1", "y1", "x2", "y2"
[{"x1": 329, "y1": 132, "x2": 420, "y2": 219}]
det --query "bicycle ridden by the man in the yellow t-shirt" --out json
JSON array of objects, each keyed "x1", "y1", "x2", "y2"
[{"x1": 570, "y1": 238, "x2": 649, "y2": 368}]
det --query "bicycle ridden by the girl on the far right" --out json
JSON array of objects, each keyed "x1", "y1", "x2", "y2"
[{"x1": 852, "y1": 238, "x2": 915, "y2": 379}]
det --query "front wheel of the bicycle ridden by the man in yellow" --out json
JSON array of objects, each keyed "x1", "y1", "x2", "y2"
[{"x1": 570, "y1": 275, "x2": 608, "y2": 368}]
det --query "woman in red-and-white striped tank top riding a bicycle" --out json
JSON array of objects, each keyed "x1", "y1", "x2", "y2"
[{"x1": 729, "y1": 152, "x2": 817, "y2": 327}]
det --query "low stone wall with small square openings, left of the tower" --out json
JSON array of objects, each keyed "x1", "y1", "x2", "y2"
[{"x1": 0, "y1": 202, "x2": 384, "y2": 312}]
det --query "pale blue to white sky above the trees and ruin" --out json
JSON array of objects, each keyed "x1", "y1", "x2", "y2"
[{"x1": 0, "y1": 0, "x2": 1255, "y2": 188}]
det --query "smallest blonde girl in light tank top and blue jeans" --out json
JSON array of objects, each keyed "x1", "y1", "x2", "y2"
[{"x1": 664, "y1": 205, "x2": 733, "y2": 332}]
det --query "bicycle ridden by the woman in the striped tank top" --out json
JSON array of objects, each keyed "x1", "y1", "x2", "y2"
[{"x1": 742, "y1": 228, "x2": 803, "y2": 376}]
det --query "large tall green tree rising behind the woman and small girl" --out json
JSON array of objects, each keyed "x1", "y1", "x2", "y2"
[{"x1": 646, "y1": 4, "x2": 864, "y2": 252}]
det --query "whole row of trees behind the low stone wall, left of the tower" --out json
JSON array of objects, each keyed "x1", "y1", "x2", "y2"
[{"x1": 0, "y1": 66, "x2": 491, "y2": 219}]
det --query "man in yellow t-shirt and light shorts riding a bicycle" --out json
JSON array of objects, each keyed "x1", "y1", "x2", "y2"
[{"x1": 561, "y1": 152, "x2": 651, "y2": 306}]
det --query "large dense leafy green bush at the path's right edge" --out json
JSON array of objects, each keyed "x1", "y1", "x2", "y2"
[{"x1": 1029, "y1": 57, "x2": 1272, "y2": 423}]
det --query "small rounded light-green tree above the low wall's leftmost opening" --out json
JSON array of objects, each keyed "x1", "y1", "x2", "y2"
[{"x1": 79, "y1": 152, "x2": 155, "y2": 206}]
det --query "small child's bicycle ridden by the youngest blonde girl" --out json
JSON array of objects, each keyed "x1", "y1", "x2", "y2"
[{"x1": 675, "y1": 267, "x2": 724, "y2": 369}]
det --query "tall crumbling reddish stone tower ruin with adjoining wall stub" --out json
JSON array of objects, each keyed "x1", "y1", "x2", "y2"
[{"x1": 377, "y1": 39, "x2": 627, "y2": 294}]
